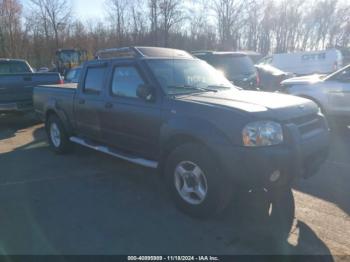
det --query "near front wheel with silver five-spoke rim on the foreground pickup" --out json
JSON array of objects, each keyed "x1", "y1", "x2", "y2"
[{"x1": 164, "y1": 143, "x2": 232, "y2": 219}]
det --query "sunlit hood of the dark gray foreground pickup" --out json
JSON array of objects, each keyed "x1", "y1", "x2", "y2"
[{"x1": 178, "y1": 90, "x2": 318, "y2": 121}]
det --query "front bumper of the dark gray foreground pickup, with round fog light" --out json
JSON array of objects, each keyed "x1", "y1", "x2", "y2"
[{"x1": 220, "y1": 114, "x2": 330, "y2": 189}]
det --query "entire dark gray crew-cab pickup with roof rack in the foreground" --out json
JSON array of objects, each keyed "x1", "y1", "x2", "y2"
[{"x1": 34, "y1": 47, "x2": 329, "y2": 223}]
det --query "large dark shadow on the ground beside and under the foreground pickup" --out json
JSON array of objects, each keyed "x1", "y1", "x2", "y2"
[{"x1": 0, "y1": 128, "x2": 331, "y2": 256}]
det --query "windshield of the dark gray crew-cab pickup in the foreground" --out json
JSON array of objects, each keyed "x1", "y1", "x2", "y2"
[{"x1": 147, "y1": 59, "x2": 234, "y2": 95}]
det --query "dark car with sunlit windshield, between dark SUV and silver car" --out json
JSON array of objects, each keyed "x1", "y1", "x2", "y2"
[{"x1": 255, "y1": 64, "x2": 295, "y2": 92}]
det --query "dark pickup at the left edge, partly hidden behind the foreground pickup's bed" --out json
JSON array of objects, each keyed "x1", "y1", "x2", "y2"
[{"x1": 0, "y1": 59, "x2": 62, "y2": 113}]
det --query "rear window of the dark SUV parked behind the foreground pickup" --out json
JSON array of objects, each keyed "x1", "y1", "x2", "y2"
[{"x1": 200, "y1": 55, "x2": 256, "y2": 79}]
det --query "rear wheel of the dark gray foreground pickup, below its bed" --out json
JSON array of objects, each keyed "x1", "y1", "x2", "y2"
[{"x1": 46, "y1": 115, "x2": 71, "y2": 154}]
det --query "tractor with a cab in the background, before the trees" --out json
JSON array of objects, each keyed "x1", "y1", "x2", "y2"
[{"x1": 55, "y1": 49, "x2": 88, "y2": 77}]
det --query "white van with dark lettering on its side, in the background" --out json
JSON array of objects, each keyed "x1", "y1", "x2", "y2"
[{"x1": 258, "y1": 49, "x2": 343, "y2": 75}]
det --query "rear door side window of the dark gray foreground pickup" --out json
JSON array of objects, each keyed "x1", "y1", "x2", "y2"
[{"x1": 83, "y1": 66, "x2": 107, "y2": 94}]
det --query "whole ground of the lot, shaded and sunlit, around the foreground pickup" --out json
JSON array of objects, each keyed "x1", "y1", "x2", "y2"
[{"x1": 0, "y1": 113, "x2": 350, "y2": 260}]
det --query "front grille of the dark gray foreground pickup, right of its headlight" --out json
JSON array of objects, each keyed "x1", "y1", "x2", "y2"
[{"x1": 290, "y1": 114, "x2": 325, "y2": 136}]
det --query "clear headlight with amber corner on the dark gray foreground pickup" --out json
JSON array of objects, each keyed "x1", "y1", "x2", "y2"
[{"x1": 242, "y1": 121, "x2": 283, "y2": 147}]
